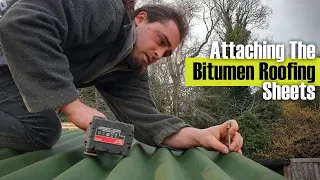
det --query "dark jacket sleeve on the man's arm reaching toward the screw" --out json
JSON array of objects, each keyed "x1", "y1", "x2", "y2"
[{"x1": 96, "y1": 71, "x2": 190, "y2": 150}]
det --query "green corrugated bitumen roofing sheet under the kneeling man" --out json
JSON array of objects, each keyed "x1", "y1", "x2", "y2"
[{"x1": 0, "y1": 130, "x2": 285, "y2": 180}]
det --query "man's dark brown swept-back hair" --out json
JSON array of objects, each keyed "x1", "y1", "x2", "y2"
[{"x1": 134, "y1": 4, "x2": 189, "y2": 42}]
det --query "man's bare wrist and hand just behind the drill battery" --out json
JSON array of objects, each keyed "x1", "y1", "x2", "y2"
[{"x1": 60, "y1": 99, "x2": 106, "y2": 131}]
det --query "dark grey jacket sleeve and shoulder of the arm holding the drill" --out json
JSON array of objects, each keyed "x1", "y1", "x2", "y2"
[{"x1": 0, "y1": 0, "x2": 121, "y2": 112}]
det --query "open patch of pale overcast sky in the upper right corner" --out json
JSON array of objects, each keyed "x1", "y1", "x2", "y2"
[{"x1": 259, "y1": 0, "x2": 320, "y2": 49}]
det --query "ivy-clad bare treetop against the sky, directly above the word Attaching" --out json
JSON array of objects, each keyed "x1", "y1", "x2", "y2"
[{"x1": 209, "y1": 0, "x2": 272, "y2": 44}]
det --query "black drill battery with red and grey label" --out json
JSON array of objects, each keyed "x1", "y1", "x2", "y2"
[{"x1": 84, "y1": 116, "x2": 134, "y2": 156}]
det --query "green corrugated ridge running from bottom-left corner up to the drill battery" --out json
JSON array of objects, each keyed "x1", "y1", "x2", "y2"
[{"x1": 0, "y1": 132, "x2": 84, "y2": 177}]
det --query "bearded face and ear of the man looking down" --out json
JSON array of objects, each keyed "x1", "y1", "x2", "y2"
[{"x1": 130, "y1": 12, "x2": 180, "y2": 73}]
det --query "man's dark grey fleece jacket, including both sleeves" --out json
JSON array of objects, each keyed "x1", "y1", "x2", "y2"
[{"x1": 0, "y1": 0, "x2": 188, "y2": 146}]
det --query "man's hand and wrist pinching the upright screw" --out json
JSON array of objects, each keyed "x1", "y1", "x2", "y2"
[{"x1": 162, "y1": 120, "x2": 243, "y2": 154}]
